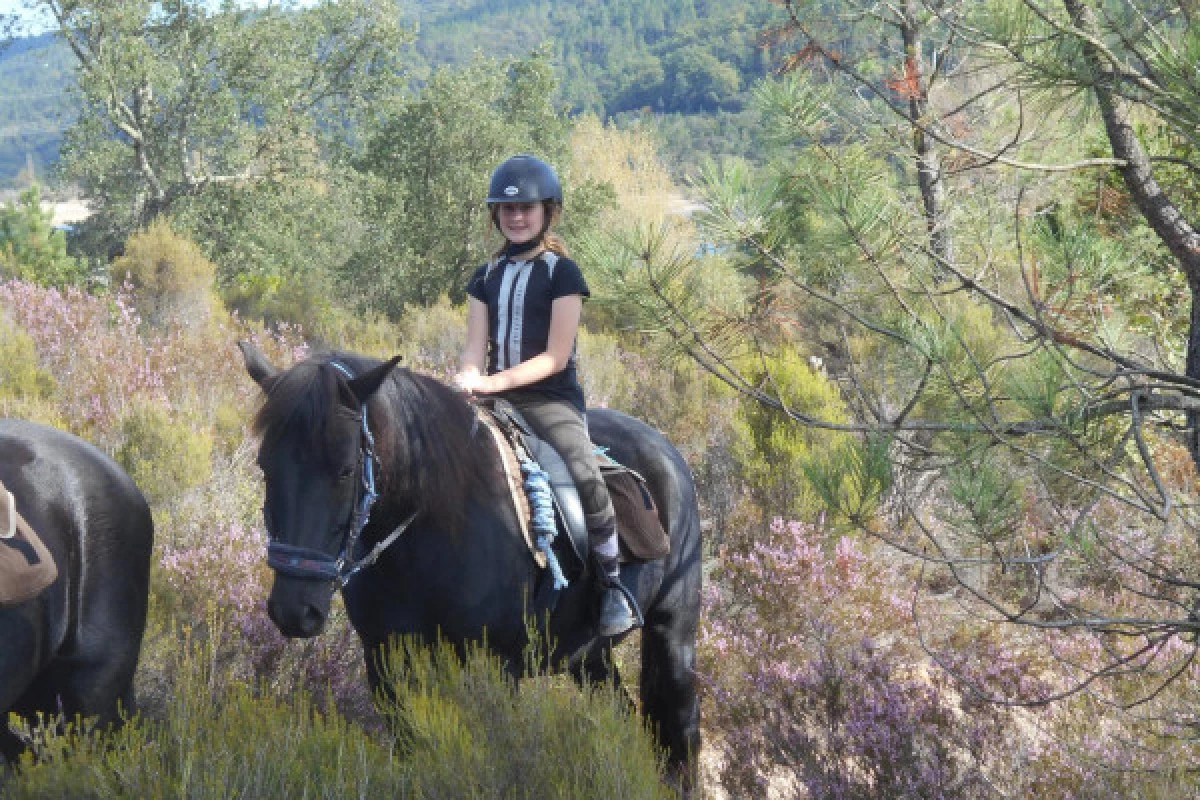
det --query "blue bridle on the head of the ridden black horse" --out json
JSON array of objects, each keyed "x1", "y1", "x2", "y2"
[{"x1": 266, "y1": 361, "x2": 416, "y2": 587}]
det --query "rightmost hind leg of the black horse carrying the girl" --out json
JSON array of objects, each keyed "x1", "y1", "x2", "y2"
[{"x1": 641, "y1": 610, "x2": 700, "y2": 792}]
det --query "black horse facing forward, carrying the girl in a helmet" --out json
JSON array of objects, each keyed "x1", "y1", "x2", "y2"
[{"x1": 241, "y1": 343, "x2": 701, "y2": 781}]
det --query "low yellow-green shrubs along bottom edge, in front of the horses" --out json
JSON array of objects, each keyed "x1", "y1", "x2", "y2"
[{"x1": 4, "y1": 634, "x2": 672, "y2": 800}]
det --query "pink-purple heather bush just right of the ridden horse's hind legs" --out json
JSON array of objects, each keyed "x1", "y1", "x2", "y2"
[{"x1": 702, "y1": 519, "x2": 1006, "y2": 798}]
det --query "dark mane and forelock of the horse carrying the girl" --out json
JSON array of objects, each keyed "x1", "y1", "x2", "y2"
[{"x1": 253, "y1": 353, "x2": 482, "y2": 531}]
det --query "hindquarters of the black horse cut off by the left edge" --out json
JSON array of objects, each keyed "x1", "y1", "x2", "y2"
[{"x1": 0, "y1": 420, "x2": 154, "y2": 759}]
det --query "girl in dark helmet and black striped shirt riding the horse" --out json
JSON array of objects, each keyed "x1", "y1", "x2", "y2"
[{"x1": 455, "y1": 156, "x2": 637, "y2": 636}]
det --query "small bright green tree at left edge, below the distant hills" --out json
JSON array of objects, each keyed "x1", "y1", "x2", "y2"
[{"x1": 0, "y1": 185, "x2": 86, "y2": 287}]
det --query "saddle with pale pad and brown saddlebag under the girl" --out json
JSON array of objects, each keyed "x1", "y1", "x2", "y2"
[{"x1": 479, "y1": 399, "x2": 671, "y2": 571}]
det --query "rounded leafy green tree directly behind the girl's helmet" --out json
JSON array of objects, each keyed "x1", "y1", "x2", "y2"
[{"x1": 343, "y1": 55, "x2": 605, "y2": 315}]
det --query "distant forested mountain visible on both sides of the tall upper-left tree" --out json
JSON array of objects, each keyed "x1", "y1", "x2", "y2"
[{"x1": 0, "y1": 0, "x2": 780, "y2": 186}]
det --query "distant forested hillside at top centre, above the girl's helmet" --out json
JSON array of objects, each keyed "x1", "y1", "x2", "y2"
[{"x1": 408, "y1": 0, "x2": 781, "y2": 116}]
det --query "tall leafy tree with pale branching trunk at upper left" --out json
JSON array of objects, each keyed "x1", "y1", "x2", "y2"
[{"x1": 34, "y1": 0, "x2": 407, "y2": 269}]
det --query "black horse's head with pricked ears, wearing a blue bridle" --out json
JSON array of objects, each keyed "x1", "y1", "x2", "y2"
[{"x1": 239, "y1": 342, "x2": 400, "y2": 637}]
